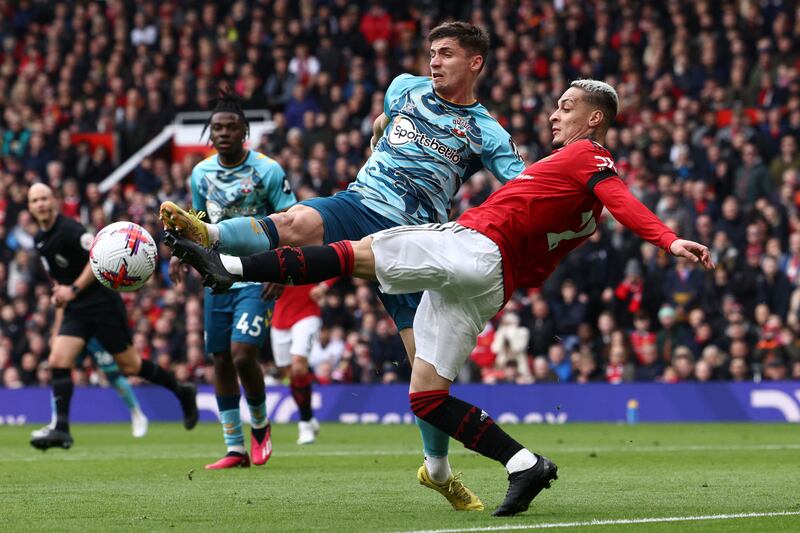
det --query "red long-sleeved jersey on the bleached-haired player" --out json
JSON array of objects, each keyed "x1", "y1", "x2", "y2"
[{"x1": 458, "y1": 139, "x2": 677, "y2": 299}]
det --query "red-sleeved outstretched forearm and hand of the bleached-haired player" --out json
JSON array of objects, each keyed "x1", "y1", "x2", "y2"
[{"x1": 594, "y1": 176, "x2": 714, "y2": 269}]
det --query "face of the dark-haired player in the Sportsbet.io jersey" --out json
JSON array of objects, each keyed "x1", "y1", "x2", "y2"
[{"x1": 431, "y1": 37, "x2": 483, "y2": 97}]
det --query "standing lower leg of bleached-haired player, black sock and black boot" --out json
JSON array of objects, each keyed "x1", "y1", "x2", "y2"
[{"x1": 409, "y1": 374, "x2": 558, "y2": 516}]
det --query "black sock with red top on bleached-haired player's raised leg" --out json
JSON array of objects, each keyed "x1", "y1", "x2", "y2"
[{"x1": 234, "y1": 241, "x2": 355, "y2": 285}]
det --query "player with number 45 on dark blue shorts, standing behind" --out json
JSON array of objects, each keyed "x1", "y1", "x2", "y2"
[{"x1": 170, "y1": 90, "x2": 297, "y2": 470}]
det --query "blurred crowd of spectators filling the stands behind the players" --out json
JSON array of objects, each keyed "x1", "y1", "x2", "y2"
[{"x1": 0, "y1": 0, "x2": 800, "y2": 387}]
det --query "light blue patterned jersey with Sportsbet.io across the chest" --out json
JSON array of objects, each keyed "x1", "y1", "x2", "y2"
[{"x1": 348, "y1": 74, "x2": 524, "y2": 225}]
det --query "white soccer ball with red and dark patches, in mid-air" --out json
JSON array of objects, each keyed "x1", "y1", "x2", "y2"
[{"x1": 89, "y1": 222, "x2": 157, "y2": 292}]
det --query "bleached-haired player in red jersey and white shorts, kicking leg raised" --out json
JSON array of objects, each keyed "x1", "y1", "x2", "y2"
[{"x1": 167, "y1": 80, "x2": 714, "y2": 516}]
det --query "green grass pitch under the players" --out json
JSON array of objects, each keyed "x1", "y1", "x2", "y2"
[{"x1": 0, "y1": 424, "x2": 800, "y2": 532}]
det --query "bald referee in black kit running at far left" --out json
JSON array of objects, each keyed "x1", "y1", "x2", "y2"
[{"x1": 28, "y1": 183, "x2": 198, "y2": 450}]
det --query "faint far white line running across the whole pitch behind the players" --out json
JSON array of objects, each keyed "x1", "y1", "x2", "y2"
[{"x1": 0, "y1": 444, "x2": 800, "y2": 463}]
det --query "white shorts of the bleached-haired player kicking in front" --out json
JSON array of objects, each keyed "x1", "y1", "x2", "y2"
[{"x1": 372, "y1": 222, "x2": 503, "y2": 381}]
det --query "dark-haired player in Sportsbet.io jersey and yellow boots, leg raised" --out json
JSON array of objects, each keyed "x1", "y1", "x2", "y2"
[{"x1": 161, "y1": 22, "x2": 524, "y2": 510}]
